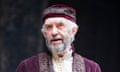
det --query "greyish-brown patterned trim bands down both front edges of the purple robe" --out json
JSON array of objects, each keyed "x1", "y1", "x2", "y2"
[{"x1": 39, "y1": 53, "x2": 85, "y2": 72}]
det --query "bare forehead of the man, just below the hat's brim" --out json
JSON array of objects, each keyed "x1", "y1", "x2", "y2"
[{"x1": 44, "y1": 17, "x2": 67, "y2": 24}]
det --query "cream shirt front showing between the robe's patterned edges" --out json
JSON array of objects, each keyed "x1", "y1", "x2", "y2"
[{"x1": 52, "y1": 49, "x2": 73, "y2": 72}]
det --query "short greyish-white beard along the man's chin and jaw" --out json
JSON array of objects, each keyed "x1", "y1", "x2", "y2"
[{"x1": 46, "y1": 33, "x2": 74, "y2": 55}]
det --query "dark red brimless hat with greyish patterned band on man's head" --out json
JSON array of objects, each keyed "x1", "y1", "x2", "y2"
[{"x1": 43, "y1": 4, "x2": 76, "y2": 23}]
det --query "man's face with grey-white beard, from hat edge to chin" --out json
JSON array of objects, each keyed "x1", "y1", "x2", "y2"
[{"x1": 42, "y1": 17, "x2": 74, "y2": 54}]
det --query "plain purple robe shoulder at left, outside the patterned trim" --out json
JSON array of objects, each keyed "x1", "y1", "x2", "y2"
[{"x1": 16, "y1": 55, "x2": 39, "y2": 72}]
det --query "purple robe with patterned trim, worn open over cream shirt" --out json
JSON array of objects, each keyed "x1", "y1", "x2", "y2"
[{"x1": 16, "y1": 53, "x2": 101, "y2": 72}]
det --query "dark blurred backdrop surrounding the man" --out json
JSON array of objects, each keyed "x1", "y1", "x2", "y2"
[{"x1": 0, "y1": 0, "x2": 119, "y2": 72}]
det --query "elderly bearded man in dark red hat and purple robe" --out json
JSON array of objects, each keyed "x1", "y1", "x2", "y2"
[{"x1": 16, "y1": 4, "x2": 101, "y2": 72}]
